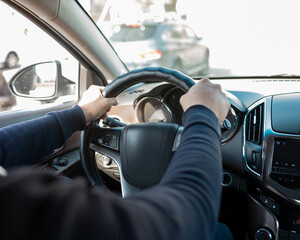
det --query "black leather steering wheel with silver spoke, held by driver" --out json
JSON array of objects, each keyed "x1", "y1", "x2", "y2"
[{"x1": 80, "y1": 67, "x2": 195, "y2": 197}]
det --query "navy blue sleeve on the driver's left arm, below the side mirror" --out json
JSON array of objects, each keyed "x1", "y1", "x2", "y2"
[{"x1": 0, "y1": 105, "x2": 85, "y2": 168}]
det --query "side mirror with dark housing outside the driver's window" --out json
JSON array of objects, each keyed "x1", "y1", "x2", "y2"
[{"x1": 9, "y1": 61, "x2": 75, "y2": 101}]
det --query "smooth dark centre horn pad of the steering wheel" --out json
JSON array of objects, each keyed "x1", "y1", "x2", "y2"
[{"x1": 120, "y1": 123, "x2": 178, "y2": 188}]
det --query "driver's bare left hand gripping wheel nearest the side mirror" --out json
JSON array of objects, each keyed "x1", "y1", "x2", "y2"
[{"x1": 78, "y1": 85, "x2": 118, "y2": 125}]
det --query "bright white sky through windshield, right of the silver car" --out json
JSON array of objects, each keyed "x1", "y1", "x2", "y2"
[{"x1": 178, "y1": 0, "x2": 300, "y2": 75}]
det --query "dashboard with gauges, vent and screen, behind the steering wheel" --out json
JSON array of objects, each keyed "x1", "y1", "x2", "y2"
[{"x1": 96, "y1": 78, "x2": 300, "y2": 239}]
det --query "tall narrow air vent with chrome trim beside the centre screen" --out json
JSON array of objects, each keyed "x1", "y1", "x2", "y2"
[{"x1": 246, "y1": 104, "x2": 264, "y2": 145}]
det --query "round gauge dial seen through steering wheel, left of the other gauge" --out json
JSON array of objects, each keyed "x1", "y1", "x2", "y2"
[{"x1": 136, "y1": 97, "x2": 173, "y2": 123}]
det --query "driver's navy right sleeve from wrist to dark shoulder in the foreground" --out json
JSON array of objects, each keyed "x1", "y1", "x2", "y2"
[{"x1": 0, "y1": 106, "x2": 221, "y2": 240}]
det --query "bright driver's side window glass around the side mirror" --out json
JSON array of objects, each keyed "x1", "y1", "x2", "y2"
[{"x1": 0, "y1": 2, "x2": 79, "y2": 114}]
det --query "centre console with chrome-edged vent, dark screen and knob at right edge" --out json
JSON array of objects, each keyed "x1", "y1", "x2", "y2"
[{"x1": 243, "y1": 94, "x2": 300, "y2": 240}]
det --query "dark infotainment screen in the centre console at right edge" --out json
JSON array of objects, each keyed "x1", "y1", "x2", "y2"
[{"x1": 271, "y1": 139, "x2": 300, "y2": 189}]
